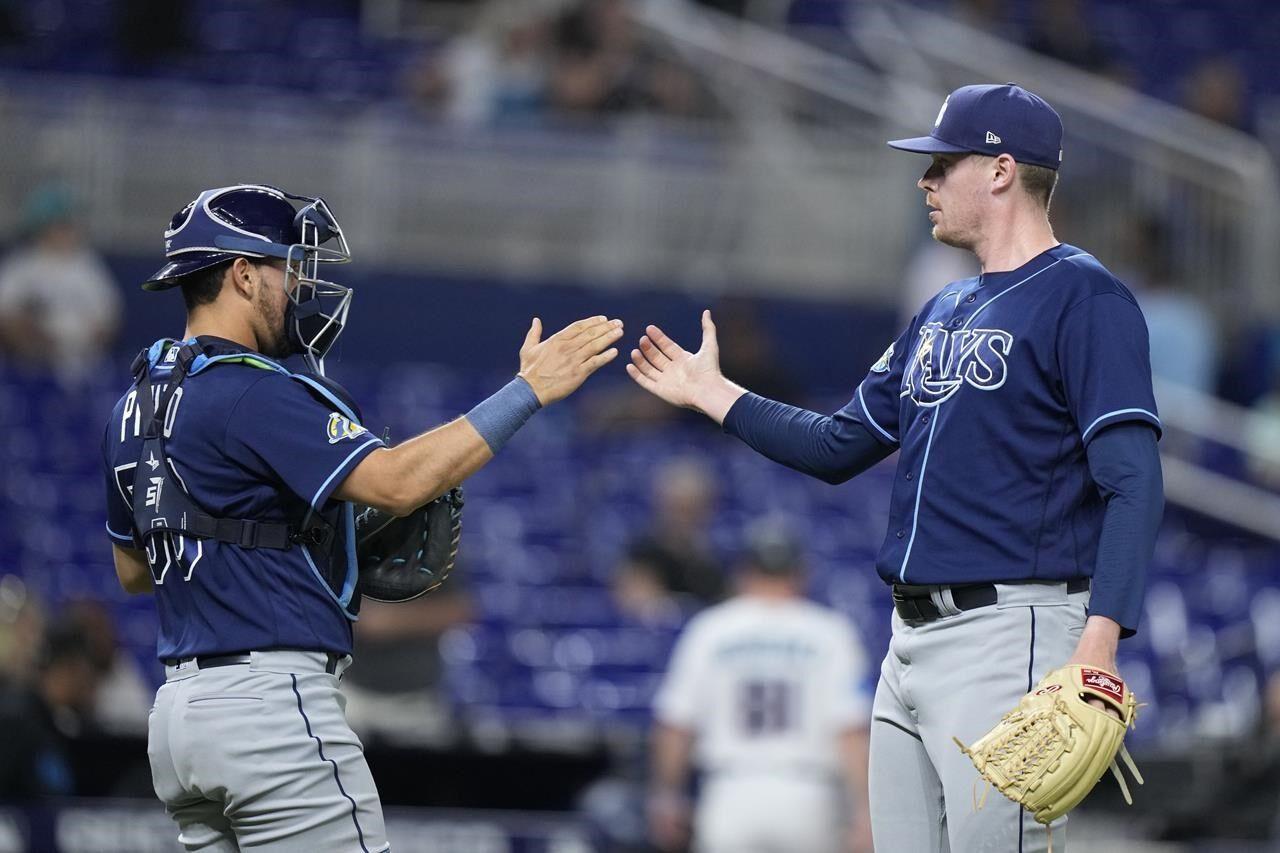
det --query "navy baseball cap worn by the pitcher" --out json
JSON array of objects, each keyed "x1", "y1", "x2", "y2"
[{"x1": 890, "y1": 83, "x2": 1062, "y2": 169}]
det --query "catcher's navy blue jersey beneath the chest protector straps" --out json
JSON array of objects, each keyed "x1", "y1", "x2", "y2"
[{"x1": 102, "y1": 338, "x2": 383, "y2": 658}]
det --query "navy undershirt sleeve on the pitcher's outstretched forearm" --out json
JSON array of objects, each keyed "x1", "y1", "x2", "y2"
[{"x1": 724, "y1": 393, "x2": 897, "y2": 484}]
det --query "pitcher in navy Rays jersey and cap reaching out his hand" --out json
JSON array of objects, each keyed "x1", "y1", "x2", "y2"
[{"x1": 627, "y1": 83, "x2": 1164, "y2": 850}]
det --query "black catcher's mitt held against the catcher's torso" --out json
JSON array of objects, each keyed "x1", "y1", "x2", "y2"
[{"x1": 356, "y1": 487, "x2": 462, "y2": 602}]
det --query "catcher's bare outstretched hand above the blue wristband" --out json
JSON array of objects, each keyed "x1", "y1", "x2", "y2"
[{"x1": 520, "y1": 316, "x2": 622, "y2": 406}]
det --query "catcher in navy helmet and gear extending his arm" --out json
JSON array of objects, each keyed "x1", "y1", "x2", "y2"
[{"x1": 104, "y1": 184, "x2": 622, "y2": 853}]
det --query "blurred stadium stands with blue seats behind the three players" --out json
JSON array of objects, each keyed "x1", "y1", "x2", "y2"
[{"x1": 0, "y1": 0, "x2": 1280, "y2": 853}]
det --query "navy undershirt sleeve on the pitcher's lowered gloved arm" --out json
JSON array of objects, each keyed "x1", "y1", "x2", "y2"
[{"x1": 1085, "y1": 421, "x2": 1165, "y2": 637}]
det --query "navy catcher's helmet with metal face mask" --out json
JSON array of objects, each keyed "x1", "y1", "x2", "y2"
[{"x1": 142, "y1": 183, "x2": 351, "y2": 374}]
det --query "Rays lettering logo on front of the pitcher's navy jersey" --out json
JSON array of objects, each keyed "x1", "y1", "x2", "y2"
[{"x1": 900, "y1": 323, "x2": 1014, "y2": 407}]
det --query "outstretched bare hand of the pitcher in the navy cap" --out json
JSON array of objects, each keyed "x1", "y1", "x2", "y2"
[{"x1": 627, "y1": 311, "x2": 745, "y2": 423}]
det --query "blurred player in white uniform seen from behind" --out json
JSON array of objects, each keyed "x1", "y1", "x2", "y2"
[{"x1": 650, "y1": 517, "x2": 870, "y2": 853}]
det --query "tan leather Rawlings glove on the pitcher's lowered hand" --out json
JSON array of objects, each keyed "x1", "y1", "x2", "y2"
[{"x1": 955, "y1": 665, "x2": 1142, "y2": 824}]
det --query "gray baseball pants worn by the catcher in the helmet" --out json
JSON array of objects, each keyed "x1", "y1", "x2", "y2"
[{"x1": 147, "y1": 652, "x2": 390, "y2": 853}]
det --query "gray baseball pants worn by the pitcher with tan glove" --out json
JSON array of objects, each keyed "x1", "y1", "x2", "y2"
[{"x1": 870, "y1": 583, "x2": 1089, "y2": 853}]
